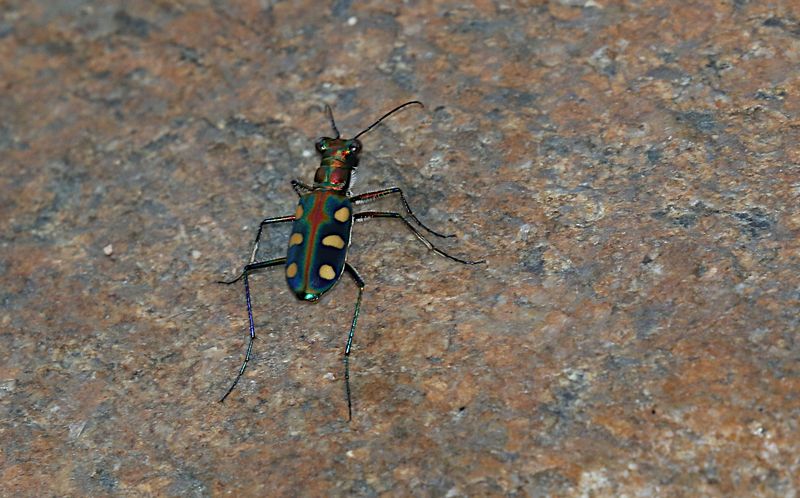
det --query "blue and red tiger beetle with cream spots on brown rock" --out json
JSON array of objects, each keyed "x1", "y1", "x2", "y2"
[{"x1": 219, "y1": 100, "x2": 484, "y2": 420}]
